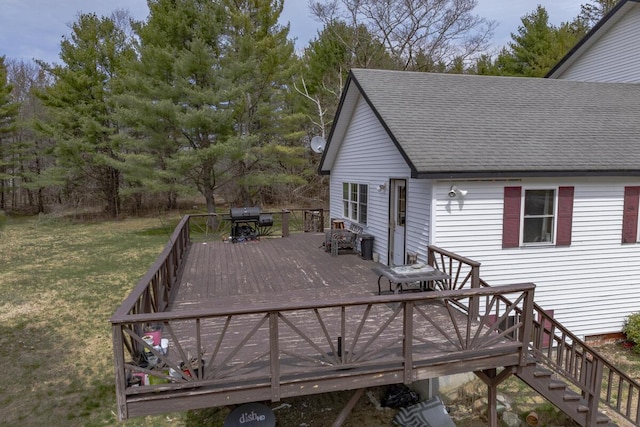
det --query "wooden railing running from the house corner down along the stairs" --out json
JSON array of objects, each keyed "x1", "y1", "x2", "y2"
[{"x1": 428, "y1": 246, "x2": 640, "y2": 425}]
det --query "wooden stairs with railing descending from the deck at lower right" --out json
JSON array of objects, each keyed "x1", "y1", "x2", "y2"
[{"x1": 480, "y1": 286, "x2": 640, "y2": 427}]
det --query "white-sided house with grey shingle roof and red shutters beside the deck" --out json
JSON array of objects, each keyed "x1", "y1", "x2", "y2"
[{"x1": 319, "y1": 69, "x2": 640, "y2": 342}]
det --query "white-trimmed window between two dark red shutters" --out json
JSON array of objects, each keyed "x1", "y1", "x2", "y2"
[{"x1": 522, "y1": 189, "x2": 556, "y2": 244}]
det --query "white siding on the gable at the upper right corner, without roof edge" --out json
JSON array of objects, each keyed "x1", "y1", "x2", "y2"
[{"x1": 556, "y1": 5, "x2": 640, "y2": 83}]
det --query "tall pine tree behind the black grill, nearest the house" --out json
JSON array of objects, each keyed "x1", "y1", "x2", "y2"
[{"x1": 222, "y1": 0, "x2": 305, "y2": 206}]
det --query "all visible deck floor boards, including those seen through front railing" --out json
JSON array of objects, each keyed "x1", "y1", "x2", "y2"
[{"x1": 170, "y1": 233, "x2": 516, "y2": 368}]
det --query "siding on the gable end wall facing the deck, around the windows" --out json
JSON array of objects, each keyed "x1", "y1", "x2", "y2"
[{"x1": 329, "y1": 96, "x2": 411, "y2": 263}]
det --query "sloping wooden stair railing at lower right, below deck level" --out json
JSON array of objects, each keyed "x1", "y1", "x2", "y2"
[{"x1": 481, "y1": 280, "x2": 640, "y2": 425}]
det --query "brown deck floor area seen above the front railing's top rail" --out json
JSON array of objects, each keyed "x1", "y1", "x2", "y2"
[{"x1": 171, "y1": 233, "x2": 378, "y2": 311}]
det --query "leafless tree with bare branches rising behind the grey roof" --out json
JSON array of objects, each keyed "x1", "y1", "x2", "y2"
[{"x1": 309, "y1": 0, "x2": 496, "y2": 70}]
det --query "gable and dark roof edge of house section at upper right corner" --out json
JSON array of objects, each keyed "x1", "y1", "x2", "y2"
[{"x1": 546, "y1": 0, "x2": 640, "y2": 83}]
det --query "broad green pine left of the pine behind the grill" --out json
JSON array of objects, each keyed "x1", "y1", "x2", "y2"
[{"x1": 118, "y1": 0, "x2": 236, "y2": 212}]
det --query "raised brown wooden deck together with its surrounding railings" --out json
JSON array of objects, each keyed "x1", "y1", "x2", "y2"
[{"x1": 112, "y1": 219, "x2": 533, "y2": 419}]
